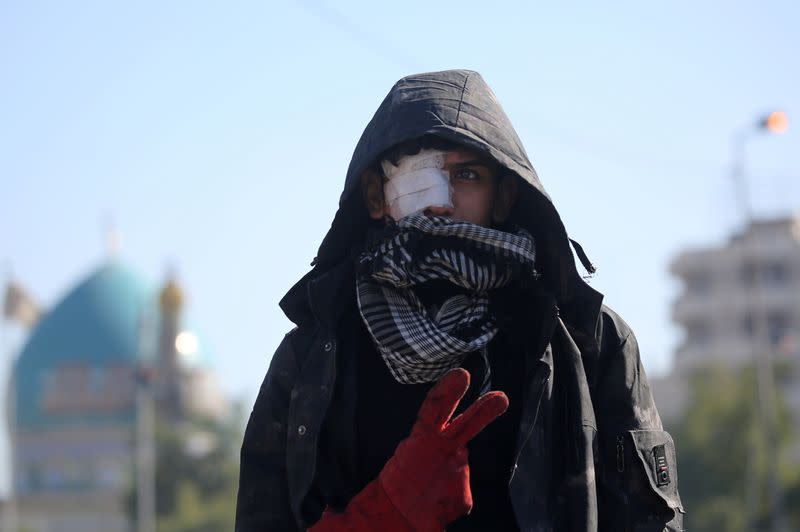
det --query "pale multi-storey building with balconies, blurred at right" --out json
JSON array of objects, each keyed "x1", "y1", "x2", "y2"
[{"x1": 654, "y1": 218, "x2": 800, "y2": 419}]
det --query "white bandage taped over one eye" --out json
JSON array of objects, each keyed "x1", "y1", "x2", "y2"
[{"x1": 381, "y1": 150, "x2": 453, "y2": 220}]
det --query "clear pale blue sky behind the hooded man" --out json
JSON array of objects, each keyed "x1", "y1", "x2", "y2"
[{"x1": 0, "y1": 0, "x2": 800, "y2": 494}]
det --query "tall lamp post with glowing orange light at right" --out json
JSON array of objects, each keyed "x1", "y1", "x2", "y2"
[{"x1": 732, "y1": 111, "x2": 789, "y2": 532}]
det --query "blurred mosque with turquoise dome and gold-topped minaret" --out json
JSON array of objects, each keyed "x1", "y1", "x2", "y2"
[{"x1": 3, "y1": 259, "x2": 228, "y2": 532}]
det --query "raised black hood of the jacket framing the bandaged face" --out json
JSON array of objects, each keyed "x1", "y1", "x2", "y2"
[{"x1": 287, "y1": 70, "x2": 599, "y2": 334}]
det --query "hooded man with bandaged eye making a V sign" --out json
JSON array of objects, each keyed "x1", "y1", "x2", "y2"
[{"x1": 237, "y1": 70, "x2": 683, "y2": 532}]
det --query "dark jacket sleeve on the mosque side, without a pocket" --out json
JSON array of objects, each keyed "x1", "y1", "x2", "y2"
[{"x1": 236, "y1": 333, "x2": 298, "y2": 532}]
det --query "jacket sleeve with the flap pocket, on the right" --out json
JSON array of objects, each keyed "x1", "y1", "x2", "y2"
[{"x1": 592, "y1": 309, "x2": 684, "y2": 531}]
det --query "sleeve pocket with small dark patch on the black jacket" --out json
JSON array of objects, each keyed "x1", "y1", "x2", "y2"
[{"x1": 626, "y1": 430, "x2": 684, "y2": 530}]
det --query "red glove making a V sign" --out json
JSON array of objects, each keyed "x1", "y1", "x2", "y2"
[{"x1": 309, "y1": 369, "x2": 508, "y2": 532}]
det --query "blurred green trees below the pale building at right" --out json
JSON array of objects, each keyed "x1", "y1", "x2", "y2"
[{"x1": 671, "y1": 367, "x2": 800, "y2": 532}]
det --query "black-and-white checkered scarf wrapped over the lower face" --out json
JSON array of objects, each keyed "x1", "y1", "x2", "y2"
[{"x1": 356, "y1": 214, "x2": 535, "y2": 384}]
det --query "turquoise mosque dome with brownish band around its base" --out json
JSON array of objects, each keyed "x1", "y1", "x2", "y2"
[{"x1": 15, "y1": 261, "x2": 158, "y2": 429}]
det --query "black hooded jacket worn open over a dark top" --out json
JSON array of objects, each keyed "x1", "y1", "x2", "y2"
[{"x1": 236, "y1": 70, "x2": 683, "y2": 532}]
